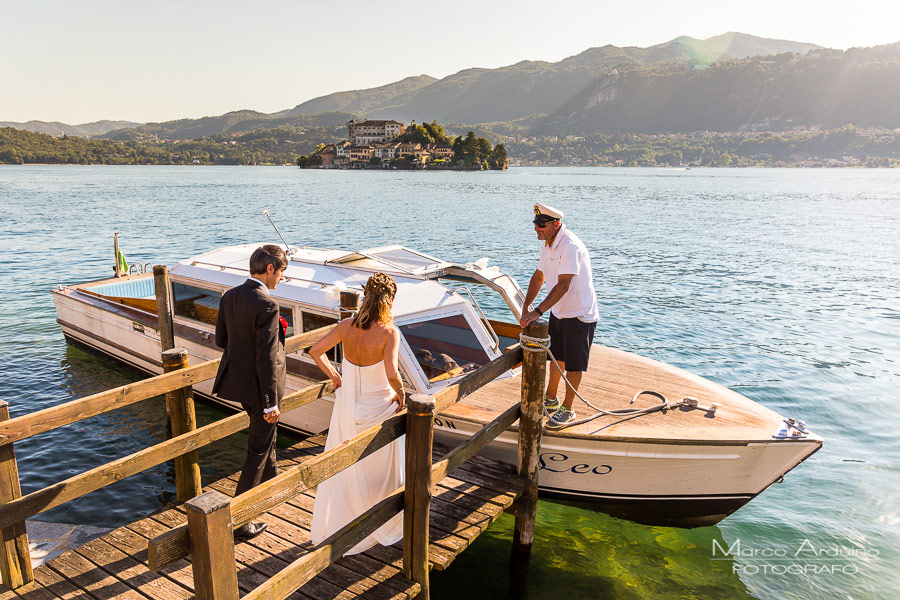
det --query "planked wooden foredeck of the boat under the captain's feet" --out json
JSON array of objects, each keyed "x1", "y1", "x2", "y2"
[{"x1": 445, "y1": 345, "x2": 782, "y2": 443}]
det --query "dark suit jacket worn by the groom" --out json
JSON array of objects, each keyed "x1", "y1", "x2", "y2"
[{"x1": 212, "y1": 279, "x2": 286, "y2": 410}]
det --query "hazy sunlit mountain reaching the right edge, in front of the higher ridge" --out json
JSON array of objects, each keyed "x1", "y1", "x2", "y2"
[{"x1": 533, "y1": 43, "x2": 900, "y2": 134}]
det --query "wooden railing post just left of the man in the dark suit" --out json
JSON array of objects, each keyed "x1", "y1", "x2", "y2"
[{"x1": 162, "y1": 348, "x2": 201, "y2": 503}]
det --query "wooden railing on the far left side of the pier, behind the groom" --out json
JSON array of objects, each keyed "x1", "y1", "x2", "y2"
[{"x1": 0, "y1": 325, "x2": 334, "y2": 588}]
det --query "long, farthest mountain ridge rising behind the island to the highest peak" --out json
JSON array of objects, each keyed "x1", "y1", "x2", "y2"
[{"x1": 93, "y1": 33, "x2": 819, "y2": 140}]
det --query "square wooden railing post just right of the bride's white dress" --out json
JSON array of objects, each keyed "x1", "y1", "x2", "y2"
[{"x1": 403, "y1": 394, "x2": 435, "y2": 600}]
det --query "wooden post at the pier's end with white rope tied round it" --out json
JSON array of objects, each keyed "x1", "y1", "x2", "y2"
[{"x1": 512, "y1": 320, "x2": 548, "y2": 558}]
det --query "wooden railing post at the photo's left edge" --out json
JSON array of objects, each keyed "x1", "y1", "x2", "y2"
[{"x1": 0, "y1": 400, "x2": 34, "y2": 589}]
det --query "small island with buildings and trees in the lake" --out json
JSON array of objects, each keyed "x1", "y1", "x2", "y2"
[{"x1": 297, "y1": 119, "x2": 509, "y2": 171}]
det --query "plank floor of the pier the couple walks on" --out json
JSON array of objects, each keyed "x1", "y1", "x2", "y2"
[{"x1": 0, "y1": 435, "x2": 528, "y2": 600}]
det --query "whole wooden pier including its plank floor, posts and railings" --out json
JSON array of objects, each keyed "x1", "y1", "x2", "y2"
[{"x1": 0, "y1": 266, "x2": 547, "y2": 600}]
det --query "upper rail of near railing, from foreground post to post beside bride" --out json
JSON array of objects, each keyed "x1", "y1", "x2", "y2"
[{"x1": 149, "y1": 412, "x2": 406, "y2": 571}]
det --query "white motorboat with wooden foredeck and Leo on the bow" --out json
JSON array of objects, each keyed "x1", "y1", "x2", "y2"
[{"x1": 53, "y1": 244, "x2": 823, "y2": 527}]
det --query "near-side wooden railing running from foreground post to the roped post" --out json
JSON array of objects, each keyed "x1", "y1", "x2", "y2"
[{"x1": 148, "y1": 321, "x2": 547, "y2": 600}]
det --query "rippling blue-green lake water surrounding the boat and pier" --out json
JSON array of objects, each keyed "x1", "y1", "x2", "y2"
[{"x1": 0, "y1": 166, "x2": 900, "y2": 599}]
